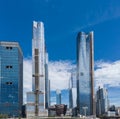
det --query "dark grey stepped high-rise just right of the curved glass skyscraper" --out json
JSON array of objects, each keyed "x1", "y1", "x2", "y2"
[{"x1": 96, "y1": 87, "x2": 109, "y2": 116}]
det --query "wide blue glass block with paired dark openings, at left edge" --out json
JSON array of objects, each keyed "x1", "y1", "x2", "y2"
[{"x1": 0, "y1": 42, "x2": 23, "y2": 117}]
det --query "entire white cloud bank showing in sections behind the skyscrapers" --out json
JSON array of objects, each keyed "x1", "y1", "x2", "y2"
[{"x1": 24, "y1": 59, "x2": 120, "y2": 102}]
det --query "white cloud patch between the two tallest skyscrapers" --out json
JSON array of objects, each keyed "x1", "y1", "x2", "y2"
[{"x1": 49, "y1": 61, "x2": 75, "y2": 90}]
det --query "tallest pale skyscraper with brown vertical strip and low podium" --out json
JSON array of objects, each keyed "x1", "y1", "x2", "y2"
[{"x1": 27, "y1": 21, "x2": 49, "y2": 117}]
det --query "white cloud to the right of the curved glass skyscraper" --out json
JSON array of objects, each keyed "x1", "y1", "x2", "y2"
[{"x1": 95, "y1": 61, "x2": 120, "y2": 87}]
